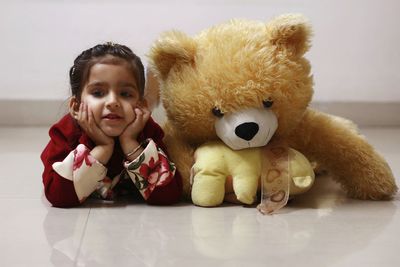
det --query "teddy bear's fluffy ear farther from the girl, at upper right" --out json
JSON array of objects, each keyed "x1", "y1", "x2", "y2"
[{"x1": 267, "y1": 14, "x2": 312, "y2": 57}]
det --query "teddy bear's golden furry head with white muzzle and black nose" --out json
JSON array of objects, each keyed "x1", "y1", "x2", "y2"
[{"x1": 150, "y1": 15, "x2": 313, "y2": 149}]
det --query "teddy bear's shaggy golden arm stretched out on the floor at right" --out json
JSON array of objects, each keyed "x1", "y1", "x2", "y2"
[{"x1": 290, "y1": 109, "x2": 397, "y2": 200}]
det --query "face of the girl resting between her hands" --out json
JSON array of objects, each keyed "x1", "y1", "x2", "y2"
[{"x1": 81, "y1": 63, "x2": 141, "y2": 137}]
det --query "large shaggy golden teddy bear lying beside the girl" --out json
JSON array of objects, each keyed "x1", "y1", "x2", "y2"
[{"x1": 150, "y1": 15, "x2": 397, "y2": 203}]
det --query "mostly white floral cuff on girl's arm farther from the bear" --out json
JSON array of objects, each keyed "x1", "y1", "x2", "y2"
[{"x1": 53, "y1": 144, "x2": 107, "y2": 203}]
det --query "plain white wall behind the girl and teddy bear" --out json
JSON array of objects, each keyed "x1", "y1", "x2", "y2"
[{"x1": 0, "y1": 0, "x2": 400, "y2": 102}]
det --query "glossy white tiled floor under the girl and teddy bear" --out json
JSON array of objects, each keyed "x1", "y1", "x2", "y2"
[{"x1": 0, "y1": 128, "x2": 400, "y2": 267}]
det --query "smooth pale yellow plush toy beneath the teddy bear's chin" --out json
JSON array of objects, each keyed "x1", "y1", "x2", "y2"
[{"x1": 191, "y1": 142, "x2": 314, "y2": 206}]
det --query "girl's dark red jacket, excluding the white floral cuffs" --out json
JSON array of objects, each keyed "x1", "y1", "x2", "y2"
[{"x1": 41, "y1": 114, "x2": 182, "y2": 207}]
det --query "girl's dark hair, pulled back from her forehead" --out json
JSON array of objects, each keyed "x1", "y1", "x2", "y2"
[{"x1": 69, "y1": 42, "x2": 145, "y2": 99}]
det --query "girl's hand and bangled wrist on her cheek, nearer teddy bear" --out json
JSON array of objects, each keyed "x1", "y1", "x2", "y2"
[{"x1": 119, "y1": 106, "x2": 151, "y2": 154}]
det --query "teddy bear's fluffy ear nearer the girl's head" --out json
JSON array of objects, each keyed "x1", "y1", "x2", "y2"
[{"x1": 149, "y1": 31, "x2": 196, "y2": 80}]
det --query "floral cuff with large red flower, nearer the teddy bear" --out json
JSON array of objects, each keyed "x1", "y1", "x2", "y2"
[{"x1": 124, "y1": 139, "x2": 176, "y2": 200}]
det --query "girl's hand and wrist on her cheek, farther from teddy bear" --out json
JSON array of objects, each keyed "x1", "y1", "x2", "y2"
[{"x1": 76, "y1": 102, "x2": 114, "y2": 146}]
